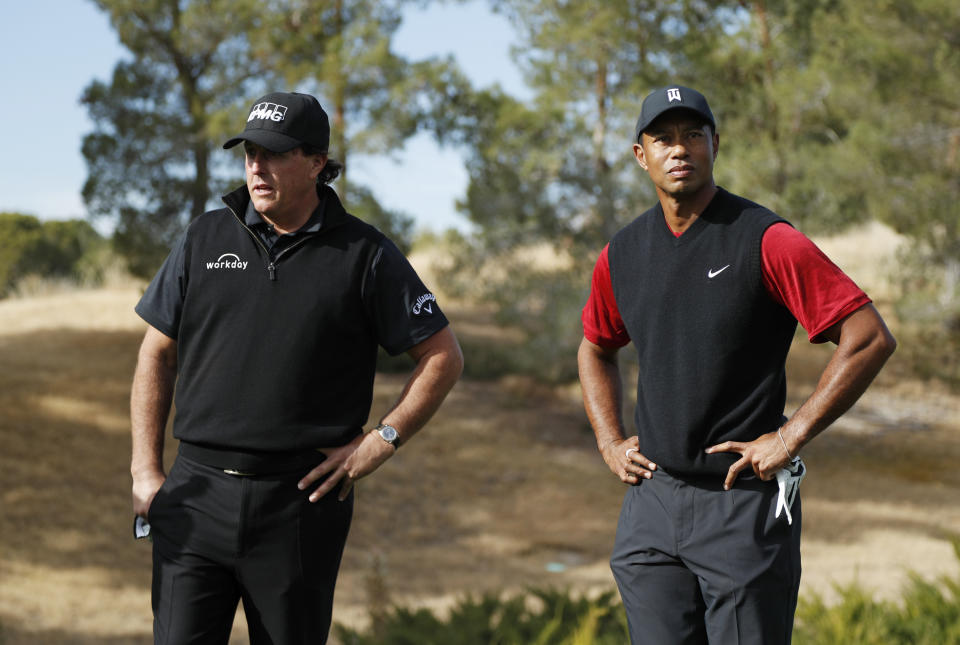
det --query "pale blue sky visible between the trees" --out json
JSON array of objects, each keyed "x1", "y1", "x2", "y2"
[{"x1": 0, "y1": 0, "x2": 524, "y2": 230}]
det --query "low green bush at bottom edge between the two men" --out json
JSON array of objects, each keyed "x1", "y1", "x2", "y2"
[{"x1": 334, "y1": 589, "x2": 629, "y2": 645}]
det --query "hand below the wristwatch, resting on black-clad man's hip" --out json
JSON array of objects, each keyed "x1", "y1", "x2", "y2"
[{"x1": 297, "y1": 432, "x2": 397, "y2": 502}]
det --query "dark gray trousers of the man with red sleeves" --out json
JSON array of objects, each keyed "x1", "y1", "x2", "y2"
[{"x1": 610, "y1": 470, "x2": 801, "y2": 645}]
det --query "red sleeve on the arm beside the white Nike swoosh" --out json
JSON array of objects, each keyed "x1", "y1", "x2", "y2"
[{"x1": 760, "y1": 224, "x2": 870, "y2": 343}]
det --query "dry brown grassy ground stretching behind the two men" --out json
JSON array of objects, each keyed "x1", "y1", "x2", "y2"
[{"x1": 0, "y1": 225, "x2": 960, "y2": 645}]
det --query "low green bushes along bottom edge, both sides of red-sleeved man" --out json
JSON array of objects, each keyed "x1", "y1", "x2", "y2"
[{"x1": 334, "y1": 540, "x2": 960, "y2": 645}]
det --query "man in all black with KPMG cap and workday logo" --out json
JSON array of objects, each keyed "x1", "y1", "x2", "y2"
[{"x1": 131, "y1": 93, "x2": 463, "y2": 645}]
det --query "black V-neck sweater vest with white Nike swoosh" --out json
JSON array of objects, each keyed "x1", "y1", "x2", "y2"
[{"x1": 608, "y1": 189, "x2": 797, "y2": 477}]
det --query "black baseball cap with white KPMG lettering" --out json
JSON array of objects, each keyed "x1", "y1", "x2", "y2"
[{"x1": 223, "y1": 92, "x2": 330, "y2": 153}]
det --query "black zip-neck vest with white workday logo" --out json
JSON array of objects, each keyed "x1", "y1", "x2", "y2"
[{"x1": 174, "y1": 188, "x2": 383, "y2": 451}]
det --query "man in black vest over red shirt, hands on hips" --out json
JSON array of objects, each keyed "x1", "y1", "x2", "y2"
[{"x1": 578, "y1": 85, "x2": 896, "y2": 645}]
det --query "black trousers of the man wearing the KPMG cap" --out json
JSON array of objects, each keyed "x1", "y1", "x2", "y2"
[{"x1": 149, "y1": 455, "x2": 353, "y2": 645}]
